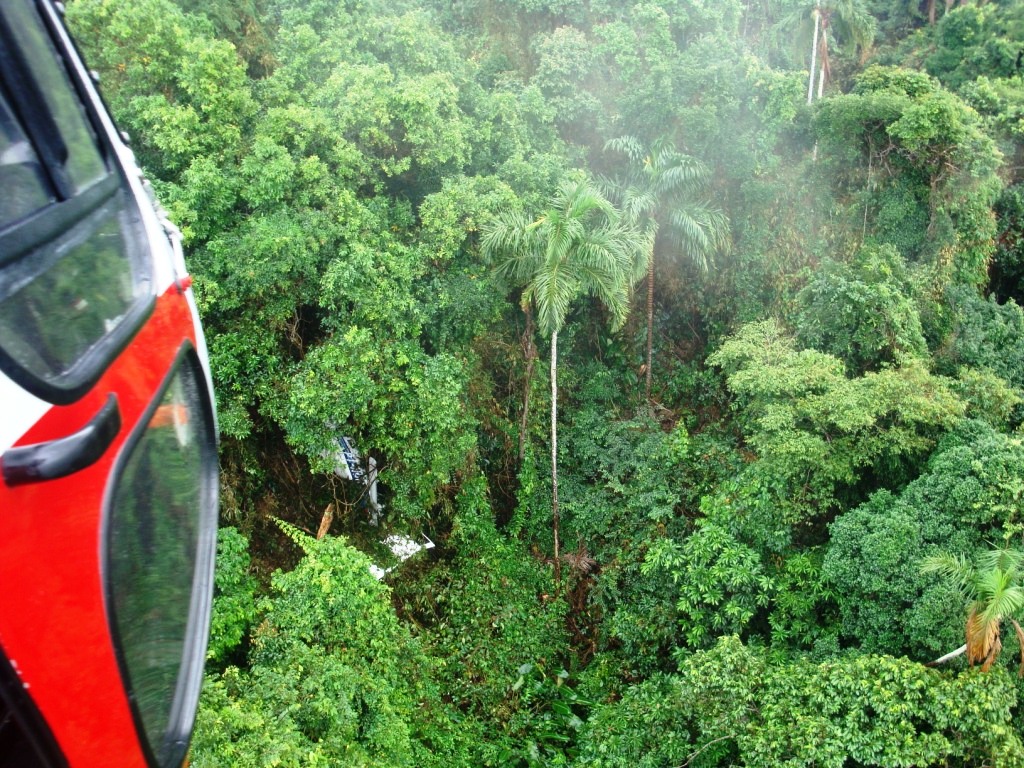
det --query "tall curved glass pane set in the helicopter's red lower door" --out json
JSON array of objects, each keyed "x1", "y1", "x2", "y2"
[{"x1": 106, "y1": 365, "x2": 216, "y2": 766}]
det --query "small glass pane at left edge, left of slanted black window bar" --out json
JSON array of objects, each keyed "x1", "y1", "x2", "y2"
[{"x1": 0, "y1": 88, "x2": 53, "y2": 227}]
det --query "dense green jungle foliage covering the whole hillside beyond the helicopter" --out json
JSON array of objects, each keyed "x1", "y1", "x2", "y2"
[{"x1": 68, "y1": 0, "x2": 1024, "y2": 768}]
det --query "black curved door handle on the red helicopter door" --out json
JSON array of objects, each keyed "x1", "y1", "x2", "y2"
[{"x1": 0, "y1": 393, "x2": 121, "y2": 485}]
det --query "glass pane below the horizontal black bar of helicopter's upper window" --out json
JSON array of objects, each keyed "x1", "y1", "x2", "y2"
[{"x1": 0, "y1": 191, "x2": 151, "y2": 387}]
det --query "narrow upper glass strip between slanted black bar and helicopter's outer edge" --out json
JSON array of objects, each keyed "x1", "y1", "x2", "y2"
[{"x1": 3, "y1": 0, "x2": 106, "y2": 194}]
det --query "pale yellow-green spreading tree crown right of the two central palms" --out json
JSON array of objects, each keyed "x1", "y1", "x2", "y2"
[{"x1": 709, "y1": 321, "x2": 966, "y2": 536}]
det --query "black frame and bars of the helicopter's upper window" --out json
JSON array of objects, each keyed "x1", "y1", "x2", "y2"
[{"x1": 0, "y1": 0, "x2": 157, "y2": 406}]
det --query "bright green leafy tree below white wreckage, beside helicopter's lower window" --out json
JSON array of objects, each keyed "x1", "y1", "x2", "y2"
[{"x1": 193, "y1": 527, "x2": 465, "y2": 768}]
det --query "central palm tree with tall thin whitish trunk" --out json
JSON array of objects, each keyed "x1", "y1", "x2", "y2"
[{"x1": 481, "y1": 179, "x2": 636, "y2": 583}]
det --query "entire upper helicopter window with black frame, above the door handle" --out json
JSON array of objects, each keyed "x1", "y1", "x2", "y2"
[{"x1": 0, "y1": 0, "x2": 155, "y2": 404}]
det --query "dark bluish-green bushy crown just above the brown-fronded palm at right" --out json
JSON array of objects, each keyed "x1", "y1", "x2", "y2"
[{"x1": 823, "y1": 422, "x2": 1024, "y2": 657}]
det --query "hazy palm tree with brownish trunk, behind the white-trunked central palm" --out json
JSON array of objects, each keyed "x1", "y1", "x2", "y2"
[{"x1": 605, "y1": 136, "x2": 729, "y2": 401}]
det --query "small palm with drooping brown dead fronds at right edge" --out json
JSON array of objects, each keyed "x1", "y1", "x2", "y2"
[{"x1": 921, "y1": 549, "x2": 1024, "y2": 674}]
